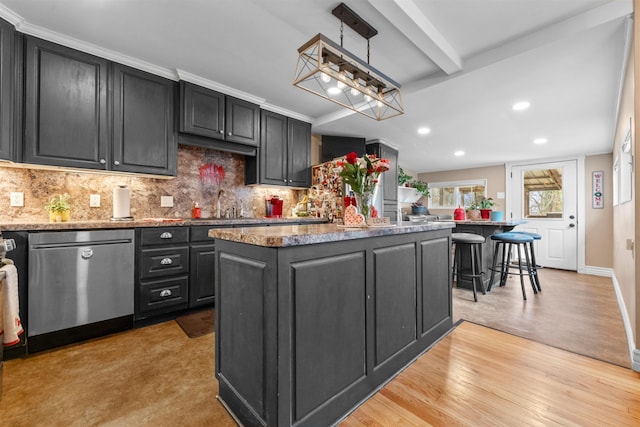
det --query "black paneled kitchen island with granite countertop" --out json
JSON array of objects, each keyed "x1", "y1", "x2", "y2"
[{"x1": 209, "y1": 222, "x2": 454, "y2": 426}]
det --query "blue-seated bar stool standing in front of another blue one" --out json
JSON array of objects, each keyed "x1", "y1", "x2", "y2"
[{"x1": 489, "y1": 232, "x2": 538, "y2": 300}]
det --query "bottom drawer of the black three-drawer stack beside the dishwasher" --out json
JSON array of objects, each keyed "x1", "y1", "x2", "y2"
[{"x1": 138, "y1": 276, "x2": 189, "y2": 313}]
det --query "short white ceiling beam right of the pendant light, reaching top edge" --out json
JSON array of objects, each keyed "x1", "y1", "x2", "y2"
[{"x1": 368, "y1": 0, "x2": 462, "y2": 74}]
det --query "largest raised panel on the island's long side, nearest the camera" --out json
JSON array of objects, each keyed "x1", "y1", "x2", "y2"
[{"x1": 290, "y1": 250, "x2": 366, "y2": 424}]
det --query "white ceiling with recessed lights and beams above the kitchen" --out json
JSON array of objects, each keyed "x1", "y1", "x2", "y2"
[{"x1": 0, "y1": 0, "x2": 632, "y2": 172}]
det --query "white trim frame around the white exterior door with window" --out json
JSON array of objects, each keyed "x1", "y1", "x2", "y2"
[{"x1": 504, "y1": 154, "x2": 587, "y2": 274}]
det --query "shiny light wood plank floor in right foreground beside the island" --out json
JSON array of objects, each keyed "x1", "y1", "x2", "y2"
[{"x1": 340, "y1": 322, "x2": 640, "y2": 427}]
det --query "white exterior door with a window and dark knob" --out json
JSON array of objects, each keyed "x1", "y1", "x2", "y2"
[{"x1": 511, "y1": 160, "x2": 578, "y2": 270}]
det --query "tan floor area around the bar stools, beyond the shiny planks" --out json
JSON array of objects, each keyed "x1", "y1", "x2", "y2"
[{"x1": 453, "y1": 268, "x2": 631, "y2": 368}]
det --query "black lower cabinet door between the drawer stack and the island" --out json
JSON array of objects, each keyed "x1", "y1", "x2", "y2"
[{"x1": 189, "y1": 244, "x2": 216, "y2": 307}]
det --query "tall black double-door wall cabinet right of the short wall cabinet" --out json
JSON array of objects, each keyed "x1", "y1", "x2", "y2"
[{"x1": 245, "y1": 110, "x2": 311, "y2": 187}]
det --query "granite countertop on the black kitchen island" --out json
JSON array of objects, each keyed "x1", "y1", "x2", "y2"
[{"x1": 209, "y1": 221, "x2": 455, "y2": 247}]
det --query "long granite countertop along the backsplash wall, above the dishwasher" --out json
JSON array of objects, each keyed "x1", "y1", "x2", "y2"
[{"x1": 0, "y1": 217, "x2": 323, "y2": 231}]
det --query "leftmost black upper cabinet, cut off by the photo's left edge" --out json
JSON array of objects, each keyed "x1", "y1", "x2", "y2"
[{"x1": 0, "y1": 19, "x2": 17, "y2": 161}]
